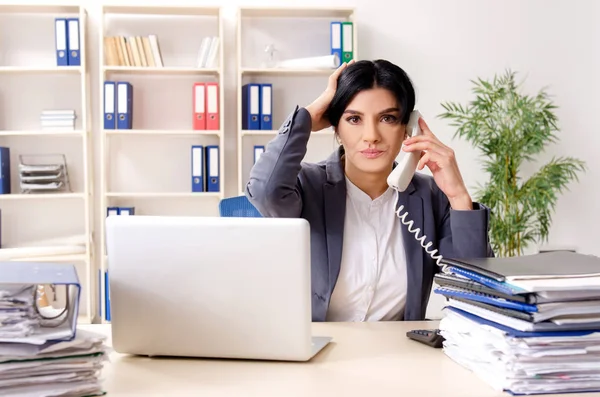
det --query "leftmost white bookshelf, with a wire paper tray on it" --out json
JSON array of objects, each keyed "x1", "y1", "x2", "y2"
[{"x1": 0, "y1": 2, "x2": 94, "y2": 323}]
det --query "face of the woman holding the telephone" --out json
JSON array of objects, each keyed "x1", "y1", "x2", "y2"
[{"x1": 337, "y1": 88, "x2": 406, "y2": 177}]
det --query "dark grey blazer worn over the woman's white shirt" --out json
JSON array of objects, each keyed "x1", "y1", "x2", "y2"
[{"x1": 245, "y1": 103, "x2": 493, "y2": 321}]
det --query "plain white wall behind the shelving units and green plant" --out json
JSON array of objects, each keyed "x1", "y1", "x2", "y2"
[{"x1": 5, "y1": 0, "x2": 600, "y2": 318}]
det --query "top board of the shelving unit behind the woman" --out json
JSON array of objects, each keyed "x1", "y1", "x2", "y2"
[{"x1": 240, "y1": 6, "x2": 354, "y2": 18}]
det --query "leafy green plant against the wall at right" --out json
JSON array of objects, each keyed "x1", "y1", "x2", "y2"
[{"x1": 438, "y1": 70, "x2": 585, "y2": 256}]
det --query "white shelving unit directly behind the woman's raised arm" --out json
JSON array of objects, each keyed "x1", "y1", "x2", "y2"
[{"x1": 236, "y1": 7, "x2": 358, "y2": 194}]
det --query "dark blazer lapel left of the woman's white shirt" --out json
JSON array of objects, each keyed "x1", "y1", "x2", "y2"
[{"x1": 323, "y1": 147, "x2": 346, "y2": 293}]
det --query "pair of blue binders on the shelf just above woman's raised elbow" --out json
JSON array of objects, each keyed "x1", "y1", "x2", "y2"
[{"x1": 242, "y1": 83, "x2": 273, "y2": 130}]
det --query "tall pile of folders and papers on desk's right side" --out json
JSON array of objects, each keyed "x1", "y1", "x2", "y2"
[{"x1": 435, "y1": 251, "x2": 600, "y2": 394}]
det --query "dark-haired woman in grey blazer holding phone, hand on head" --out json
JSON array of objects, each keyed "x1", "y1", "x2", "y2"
[{"x1": 246, "y1": 60, "x2": 493, "y2": 321}]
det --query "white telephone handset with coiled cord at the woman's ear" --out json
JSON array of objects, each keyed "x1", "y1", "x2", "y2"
[{"x1": 387, "y1": 110, "x2": 442, "y2": 266}]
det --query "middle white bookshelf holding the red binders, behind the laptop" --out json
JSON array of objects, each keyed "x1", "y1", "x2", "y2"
[{"x1": 97, "y1": 5, "x2": 225, "y2": 323}]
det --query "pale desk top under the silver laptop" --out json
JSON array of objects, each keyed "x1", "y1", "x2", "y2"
[{"x1": 80, "y1": 322, "x2": 600, "y2": 397}]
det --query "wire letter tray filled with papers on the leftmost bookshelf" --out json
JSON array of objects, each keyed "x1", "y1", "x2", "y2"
[{"x1": 19, "y1": 154, "x2": 70, "y2": 193}]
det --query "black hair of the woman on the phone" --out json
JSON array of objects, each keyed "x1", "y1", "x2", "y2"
[{"x1": 326, "y1": 59, "x2": 415, "y2": 127}]
